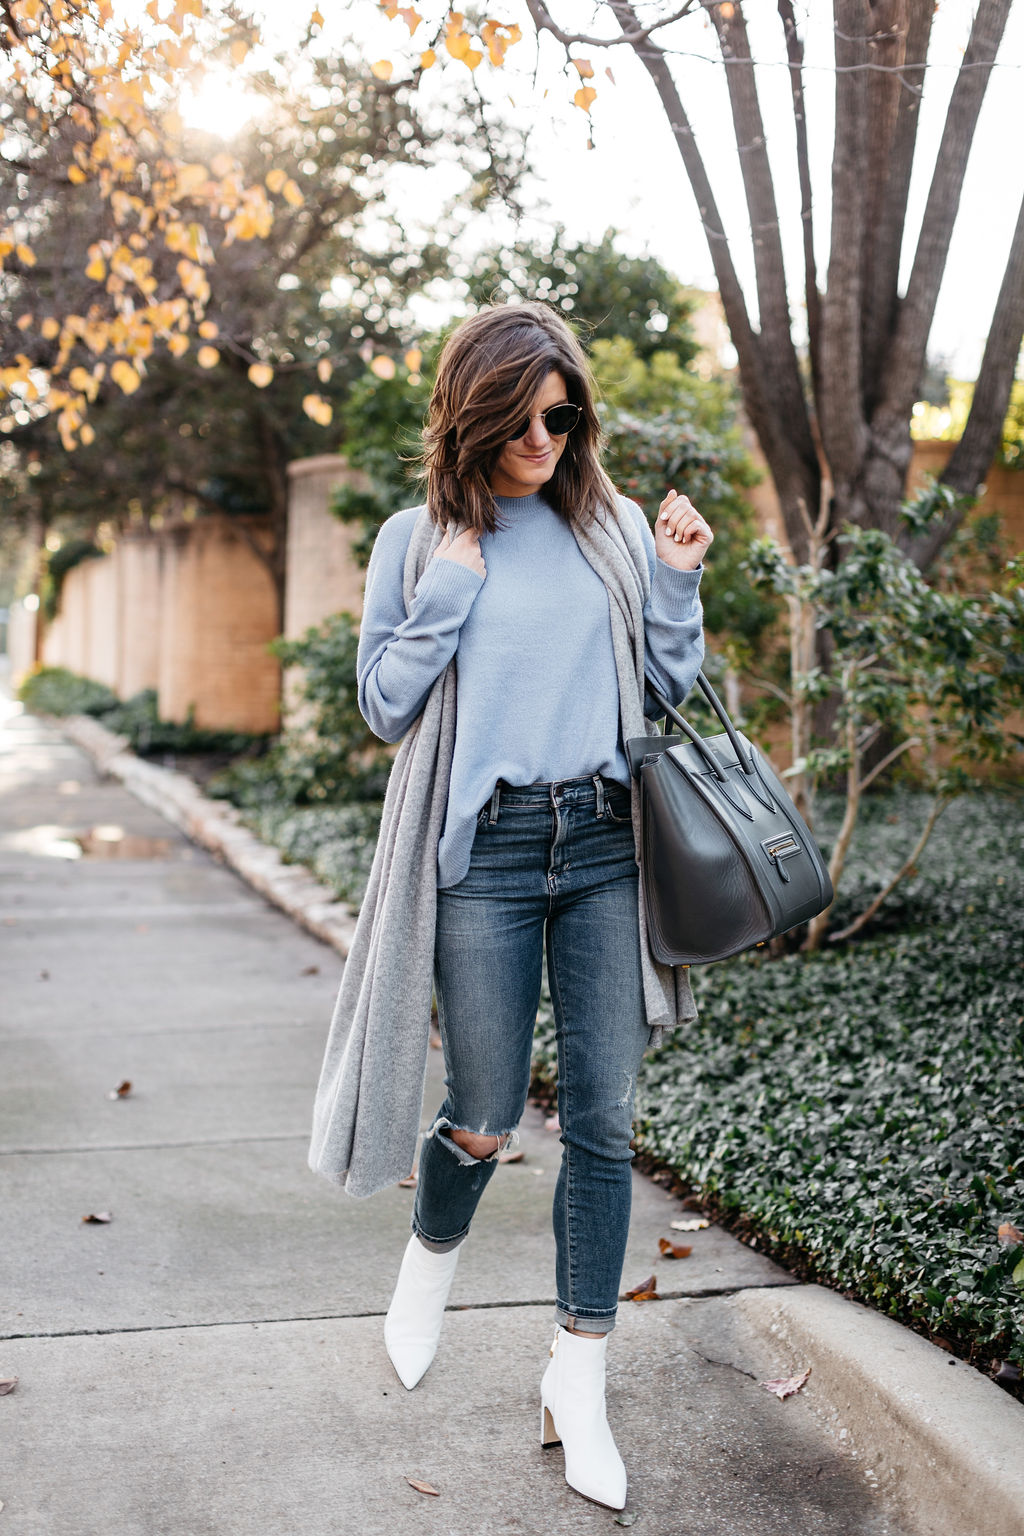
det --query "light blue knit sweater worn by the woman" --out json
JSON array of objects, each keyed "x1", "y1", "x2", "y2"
[{"x1": 356, "y1": 495, "x2": 703, "y2": 888}]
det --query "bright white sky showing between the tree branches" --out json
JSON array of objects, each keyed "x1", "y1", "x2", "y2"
[{"x1": 186, "y1": 0, "x2": 1024, "y2": 378}]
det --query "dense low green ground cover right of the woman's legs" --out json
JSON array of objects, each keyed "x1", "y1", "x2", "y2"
[{"x1": 536, "y1": 793, "x2": 1024, "y2": 1367}]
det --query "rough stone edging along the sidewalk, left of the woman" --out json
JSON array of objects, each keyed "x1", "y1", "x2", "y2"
[{"x1": 60, "y1": 714, "x2": 356, "y2": 957}]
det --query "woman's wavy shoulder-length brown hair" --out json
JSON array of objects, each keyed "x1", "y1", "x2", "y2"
[{"x1": 422, "y1": 303, "x2": 617, "y2": 533}]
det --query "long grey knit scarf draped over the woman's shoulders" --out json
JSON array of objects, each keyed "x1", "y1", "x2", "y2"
[{"x1": 309, "y1": 508, "x2": 697, "y2": 1197}]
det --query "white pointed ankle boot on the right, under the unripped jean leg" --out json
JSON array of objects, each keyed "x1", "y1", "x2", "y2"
[{"x1": 540, "y1": 1329, "x2": 626, "y2": 1510}]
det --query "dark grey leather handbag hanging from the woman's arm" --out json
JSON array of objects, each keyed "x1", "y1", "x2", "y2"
[{"x1": 626, "y1": 673, "x2": 832, "y2": 965}]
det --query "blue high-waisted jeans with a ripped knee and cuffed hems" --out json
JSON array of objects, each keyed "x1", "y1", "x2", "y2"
[{"x1": 413, "y1": 777, "x2": 651, "y2": 1333}]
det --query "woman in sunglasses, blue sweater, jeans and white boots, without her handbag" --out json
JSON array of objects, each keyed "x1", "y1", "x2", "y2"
[{"x1": 310, "y1": 304, "x2": 712, "y2": 1508}]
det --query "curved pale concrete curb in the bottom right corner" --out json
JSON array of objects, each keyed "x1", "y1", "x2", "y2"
[{"x1": 732, "y1": 1286, "x2": 1024, "y2": 1536}]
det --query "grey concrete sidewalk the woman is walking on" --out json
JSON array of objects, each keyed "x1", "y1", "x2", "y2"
[{"x1": 0, "y1": 681, "x2": 1024, "y2": 1536}]
